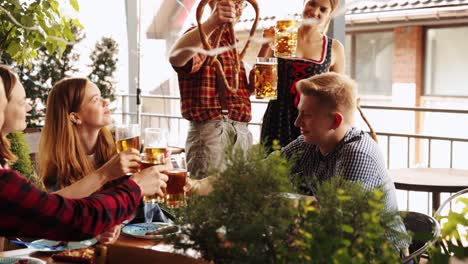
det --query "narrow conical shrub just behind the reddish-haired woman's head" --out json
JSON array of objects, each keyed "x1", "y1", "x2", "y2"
[{"x1": 88, "y1": 37, "x2": 119, "y2": 102}]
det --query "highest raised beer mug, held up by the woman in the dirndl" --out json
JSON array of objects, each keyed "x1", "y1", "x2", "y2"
[{"x1": 274, "y1": 19, "x2": 298, "y2": 57}]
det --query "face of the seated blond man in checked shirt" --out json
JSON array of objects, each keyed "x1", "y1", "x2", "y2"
[{"x1": 294, "y1": 95, "x2": 334, "y2": 145}]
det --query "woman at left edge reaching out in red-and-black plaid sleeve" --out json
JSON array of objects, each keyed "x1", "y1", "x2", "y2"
[{"x1": 0, "y1": 65, "x2": 167, "y2": 241}]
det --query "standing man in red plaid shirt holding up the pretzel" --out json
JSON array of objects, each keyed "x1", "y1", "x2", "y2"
[{"x1": 169, "y1": 0, "x2": 252, "y2": 177}]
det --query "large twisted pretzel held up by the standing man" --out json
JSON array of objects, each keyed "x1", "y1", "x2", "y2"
[{"x1": 196, "y1": 0, "x2": 259, "y2": 93}]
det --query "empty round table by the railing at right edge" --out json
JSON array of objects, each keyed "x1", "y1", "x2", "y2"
[{"x1": 389, "y1": 168, "x2": 468, "y2": 212}]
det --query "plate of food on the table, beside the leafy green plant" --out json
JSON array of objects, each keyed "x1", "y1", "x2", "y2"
[{"x1": 122, "y1": 222, "x2": 180, "y2": 239}]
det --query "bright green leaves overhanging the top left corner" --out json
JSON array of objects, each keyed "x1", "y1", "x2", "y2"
[{"x1": 0, "y1": 0, "x2": 82, "y2": 65}]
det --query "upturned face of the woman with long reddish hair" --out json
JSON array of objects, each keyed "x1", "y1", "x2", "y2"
[{"x1": 75, "y1": 81, "x2": 112, "y2": 129}]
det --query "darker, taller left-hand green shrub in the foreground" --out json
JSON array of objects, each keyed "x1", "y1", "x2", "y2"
[{"x1": 171, "y1": 143, "x2": 294, "y2": 263}]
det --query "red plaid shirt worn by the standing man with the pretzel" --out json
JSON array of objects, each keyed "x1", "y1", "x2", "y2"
[{"x1": 174, "y1": 27, "x2": 252, "y2": 122}]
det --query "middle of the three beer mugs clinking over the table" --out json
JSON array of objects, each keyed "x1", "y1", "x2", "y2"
[{"x1": 141, "y1": 128, "x2": 168, "y2": 206}]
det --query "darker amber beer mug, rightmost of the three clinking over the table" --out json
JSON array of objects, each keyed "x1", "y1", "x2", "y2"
[{"x1": 164, "y1": 155, "x2": 188, "y2": 208}]
